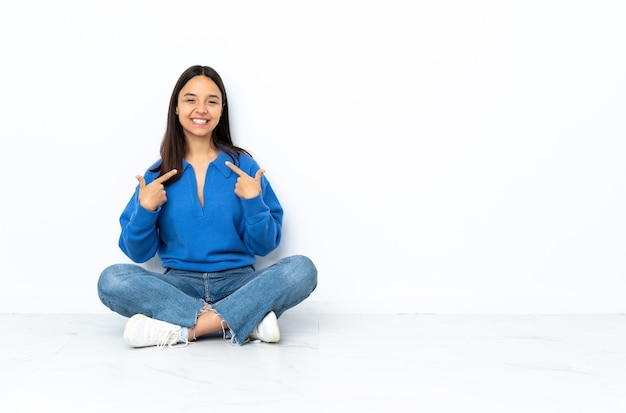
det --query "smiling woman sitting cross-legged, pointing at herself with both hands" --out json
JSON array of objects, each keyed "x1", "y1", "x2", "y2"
[{"x1": 98, "y1": 66, "x2": 317, "y2": 347}]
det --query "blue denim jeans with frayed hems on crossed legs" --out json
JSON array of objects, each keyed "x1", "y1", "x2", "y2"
[{"x1": 98, "y1": 255, "x2": 317, "y2": 345}]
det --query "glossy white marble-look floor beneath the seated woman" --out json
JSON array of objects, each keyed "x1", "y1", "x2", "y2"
[{"x1": 0, "y1": 309, "x2": 626, "y2": 413}]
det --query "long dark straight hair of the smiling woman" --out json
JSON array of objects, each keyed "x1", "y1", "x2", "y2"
[{"x1": 151, "y1": 65, "x2": 250, "y2": 185}]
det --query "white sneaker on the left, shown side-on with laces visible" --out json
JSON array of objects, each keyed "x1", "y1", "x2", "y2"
[{"x1": 124, "y1": 314, "x2": 189, "y2": 348}]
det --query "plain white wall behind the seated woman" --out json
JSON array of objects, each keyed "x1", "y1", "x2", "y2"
[{"x1": 0, "y1": 0, "x2": 626, "y2": 313}]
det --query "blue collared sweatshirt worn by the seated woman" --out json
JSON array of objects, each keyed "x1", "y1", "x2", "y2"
[{"x1": 119, "y1": 151, "x2": 283, "y2": 272}]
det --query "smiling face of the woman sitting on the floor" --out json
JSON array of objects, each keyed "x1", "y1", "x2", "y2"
[{"x1": 176, "y1": 75, "x2": 223, "y2": 142}]
